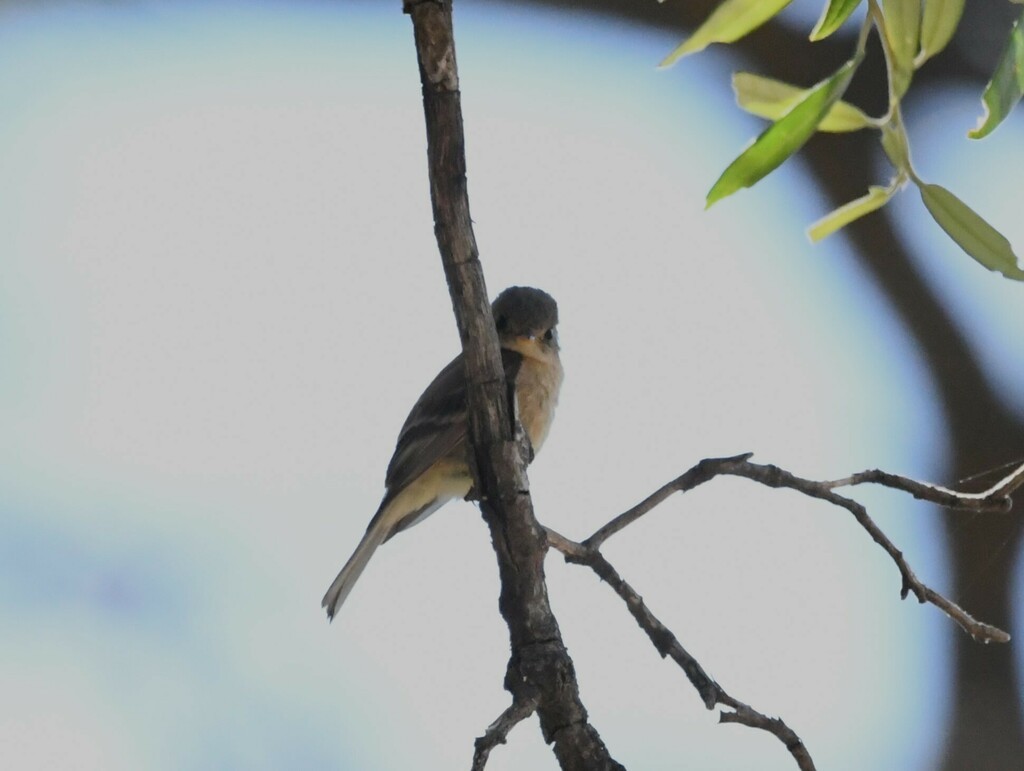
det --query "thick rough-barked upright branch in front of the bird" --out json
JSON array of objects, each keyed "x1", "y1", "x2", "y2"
[{"x1": 403, "y1": 0, "x2": 622, "y2": 771}]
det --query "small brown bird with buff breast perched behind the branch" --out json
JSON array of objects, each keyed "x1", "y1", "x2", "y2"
[{"x1": 321, "y1": 287, "x2": 563, "y2": 620}]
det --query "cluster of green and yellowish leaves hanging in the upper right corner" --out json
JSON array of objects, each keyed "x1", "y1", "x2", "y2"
[{"x1": 662, "y1": 0, "x2": 1024, "y2": 281}]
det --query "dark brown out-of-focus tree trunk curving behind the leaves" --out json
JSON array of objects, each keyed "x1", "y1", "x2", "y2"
[{"x1": 495, "y1": 0, "x2": 1024, "y2": 771}]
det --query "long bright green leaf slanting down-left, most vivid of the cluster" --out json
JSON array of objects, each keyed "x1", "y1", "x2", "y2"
[{"x1": 707, "y1": 57, "x2": 860, "y2": 207}]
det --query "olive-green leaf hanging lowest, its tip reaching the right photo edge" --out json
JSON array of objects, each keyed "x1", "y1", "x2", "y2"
[{"x1": 918, "y1": 182, "x2": 1024, "y2": 281}]
